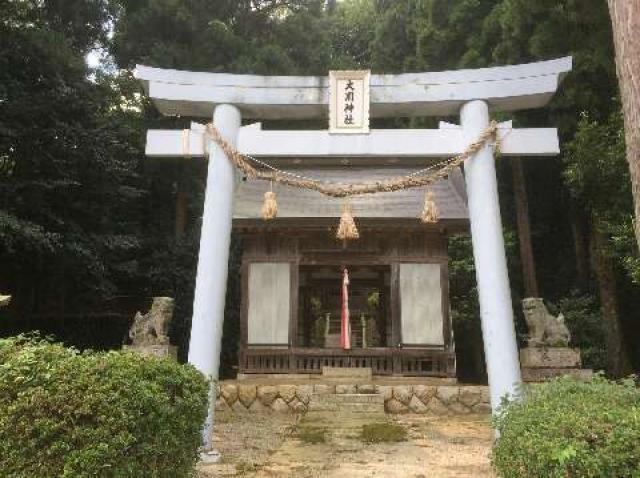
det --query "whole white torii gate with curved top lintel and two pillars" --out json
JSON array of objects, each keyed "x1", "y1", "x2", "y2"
[{"x1": 136, "y1": 57, "x2": 571, "y2": 452}]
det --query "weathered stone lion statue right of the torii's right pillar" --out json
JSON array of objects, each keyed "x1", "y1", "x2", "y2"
[{"x1": 522, "y1": 298, "x2": 571, "y2": 347}]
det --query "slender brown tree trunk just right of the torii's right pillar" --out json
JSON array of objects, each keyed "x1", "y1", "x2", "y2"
[{"x1": 511, "y1": 158, "x2": 540, "y2": 297}]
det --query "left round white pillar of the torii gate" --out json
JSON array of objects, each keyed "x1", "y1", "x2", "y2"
[{"x1": 189, "y1": 104, "x2": 241, "y2": 457}]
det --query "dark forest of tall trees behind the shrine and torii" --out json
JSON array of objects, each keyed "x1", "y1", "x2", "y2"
[{"x1": 0, "y1": 0, "x2": 640, "y2": 381}]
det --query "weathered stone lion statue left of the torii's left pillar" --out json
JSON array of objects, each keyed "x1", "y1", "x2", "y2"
[{"x1": 129, "y1": 297, "x2": 173, "y2": 346}]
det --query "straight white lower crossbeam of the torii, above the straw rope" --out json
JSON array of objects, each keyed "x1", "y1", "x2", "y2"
[{"x1": 146, "y1": 121, "x2": 560, "y2": 159}]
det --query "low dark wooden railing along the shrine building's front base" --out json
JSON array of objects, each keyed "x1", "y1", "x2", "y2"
[{"x1": 240, "y1": 348, "x2": 455, "y2": 377}]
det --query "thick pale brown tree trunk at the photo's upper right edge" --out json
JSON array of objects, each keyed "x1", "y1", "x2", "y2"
[{"x1": 607, "y1": 0, "x2": 640, "y2": 252}]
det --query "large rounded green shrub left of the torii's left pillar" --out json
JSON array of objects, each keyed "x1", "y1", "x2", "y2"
[{"x1": 0, "y1": 337, "x2": 207, "y2": 478}]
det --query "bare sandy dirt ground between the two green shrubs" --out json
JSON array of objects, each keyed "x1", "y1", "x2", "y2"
[{"x1": 199, "y1": 413, "x2": 494, "y2": 478}]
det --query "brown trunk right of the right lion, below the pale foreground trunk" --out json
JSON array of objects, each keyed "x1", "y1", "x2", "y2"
[{"x1": 591, "y1": 224, "x2": 632, "y2": 377}]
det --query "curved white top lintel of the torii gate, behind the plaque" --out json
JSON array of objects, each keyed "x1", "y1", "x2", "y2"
[{"x1": 135, "y1": 57, "x2": 571, "y2": 119}]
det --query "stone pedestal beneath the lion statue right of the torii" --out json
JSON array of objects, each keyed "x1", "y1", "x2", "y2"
[{"x1": 520, "y1": 347, "x2": 593, "y2": 382}]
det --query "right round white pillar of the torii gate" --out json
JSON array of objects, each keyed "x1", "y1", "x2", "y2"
[{"x1": 460, "y1": 100, "x2": 522, "y2": 412}]
